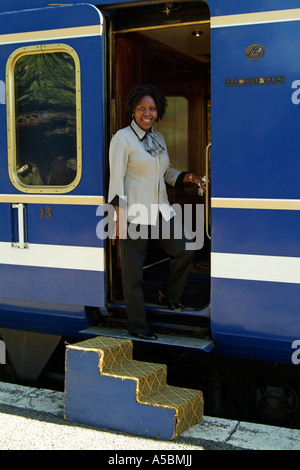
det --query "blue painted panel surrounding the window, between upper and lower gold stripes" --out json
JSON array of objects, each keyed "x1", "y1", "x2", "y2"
[{"x1": 0, "y1": 40, "x2": 105, "y2": 200}]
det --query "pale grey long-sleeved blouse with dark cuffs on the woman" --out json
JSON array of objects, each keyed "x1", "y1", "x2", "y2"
[{"x1": 108, "y1": 121, "x2": 185, "y2": 225}]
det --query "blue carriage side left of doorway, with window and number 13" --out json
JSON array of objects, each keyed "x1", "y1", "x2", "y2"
[{"x1": 0, "y1": 5, "x2": 105, "y2": 308}]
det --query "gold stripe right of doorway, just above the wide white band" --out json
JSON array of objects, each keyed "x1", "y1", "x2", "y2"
[{"x1": 211, "y1": 198, "x2": 300, "y2": 211}]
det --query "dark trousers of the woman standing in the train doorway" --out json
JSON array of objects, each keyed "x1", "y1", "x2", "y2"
[{"x1": 120, "y1": 217, "x2": 194, "y2": 334}]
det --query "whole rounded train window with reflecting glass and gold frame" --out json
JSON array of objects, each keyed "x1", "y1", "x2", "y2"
[{"x1": 6, "y1": 44, "x2": 81, "y2": 192}]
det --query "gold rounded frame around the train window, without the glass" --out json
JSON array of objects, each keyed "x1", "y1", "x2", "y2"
[{"x1": 6, "y1": 44, "x2": 82, "y2": 194}]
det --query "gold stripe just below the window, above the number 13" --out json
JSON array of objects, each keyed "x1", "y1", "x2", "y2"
[{"x1": 0, "y1": 194, "x2": 105, "y2": 206}]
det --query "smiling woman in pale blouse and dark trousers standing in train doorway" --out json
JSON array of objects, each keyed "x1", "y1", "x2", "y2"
[{"x1": 108, "y1": 85, "x2": 201, "y2": 340}]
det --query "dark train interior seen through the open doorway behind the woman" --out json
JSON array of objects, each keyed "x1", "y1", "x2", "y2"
[{"x1": 104, "y1": 2, "x2": 210, "y2": 324}]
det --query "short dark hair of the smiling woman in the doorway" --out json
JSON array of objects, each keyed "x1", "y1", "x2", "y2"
[{"x1": 126, "y1": 83, "x2": 168, "y2": 121}]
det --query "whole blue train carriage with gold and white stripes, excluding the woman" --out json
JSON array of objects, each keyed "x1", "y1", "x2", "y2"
[{"x1": 0, "y1": 0, "x2": 300, "y2": 422}]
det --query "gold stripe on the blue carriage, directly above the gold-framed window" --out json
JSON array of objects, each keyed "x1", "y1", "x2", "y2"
[{"x1": 0, "y1": 25, "x2": 102, "y2": 44}]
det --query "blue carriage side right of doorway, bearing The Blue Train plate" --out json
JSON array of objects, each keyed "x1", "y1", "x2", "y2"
[{"x1": 212, "y1": 5, "x2": 300, "y2": 363}]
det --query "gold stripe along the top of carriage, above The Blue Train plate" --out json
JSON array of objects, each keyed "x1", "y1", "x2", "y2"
[{"x1": 211, "y1": 8, "x2": 300, "y2": 28}]
